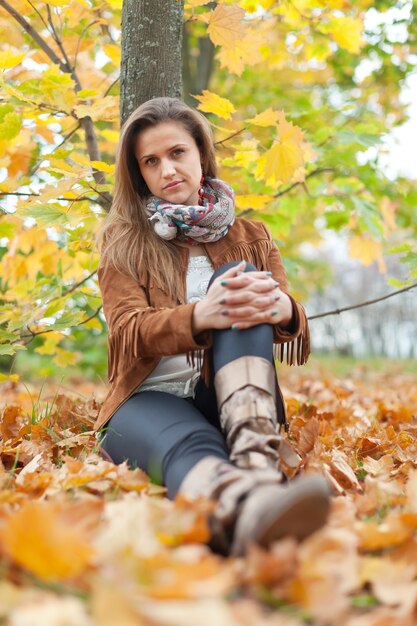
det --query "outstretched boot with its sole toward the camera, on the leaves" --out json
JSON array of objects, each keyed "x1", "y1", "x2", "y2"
[{"x1": 179, "y1": 457, "x2": 330, "y2": 556}]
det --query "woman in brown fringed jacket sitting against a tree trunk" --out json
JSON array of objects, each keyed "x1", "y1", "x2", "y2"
[{"x1": 95, "y1": 98, "x2": 329, "y2": 555}]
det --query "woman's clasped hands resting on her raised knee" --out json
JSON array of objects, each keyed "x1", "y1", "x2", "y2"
[{"x1": 193, "y1": 261, "x2": 292, "y2": 333}]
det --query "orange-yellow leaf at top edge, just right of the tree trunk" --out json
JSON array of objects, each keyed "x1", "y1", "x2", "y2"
[{"x1": 207, "y1": 4, "x2": 245, "y2": 48}]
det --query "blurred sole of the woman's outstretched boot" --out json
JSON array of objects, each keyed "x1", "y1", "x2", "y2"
[{"x1": 231, "y1": 476, "x2": 330, "y2": 556}]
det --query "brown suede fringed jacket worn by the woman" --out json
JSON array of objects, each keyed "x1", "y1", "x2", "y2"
[{"x1": 94, "y1": 218, "x2": 310, "y2": 430}]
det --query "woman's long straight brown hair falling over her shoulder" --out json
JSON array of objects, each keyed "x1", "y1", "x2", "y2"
[{"x1": 97, "y1": 98, "x2": 217, "y2": 298}]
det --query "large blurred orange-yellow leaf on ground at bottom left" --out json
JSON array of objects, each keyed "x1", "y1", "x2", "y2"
[{"x1": 0, "y1": 502, "x2": 92, "y2": 581}]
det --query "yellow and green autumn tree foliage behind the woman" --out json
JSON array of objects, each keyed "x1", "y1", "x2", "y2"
[{"x1": 0, "y1": 0, "x2": 417, "y2": 366}]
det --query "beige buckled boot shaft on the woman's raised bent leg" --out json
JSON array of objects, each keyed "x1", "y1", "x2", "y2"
[{"x1": 214, "y1": 356, "x2": 281, "y2": 472}]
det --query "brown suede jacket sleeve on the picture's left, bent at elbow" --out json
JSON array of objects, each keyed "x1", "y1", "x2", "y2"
[{"x1": 98, "y1": 266, "x2": 211, "y2": 381}]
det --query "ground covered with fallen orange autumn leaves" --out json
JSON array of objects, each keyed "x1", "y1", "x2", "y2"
[{"x1": 0, "y1": 368, "x2": 417, "y2": 626}]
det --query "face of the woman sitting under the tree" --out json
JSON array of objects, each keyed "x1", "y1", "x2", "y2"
[{"x1": 135, "y1": 122, "x2": 201, "y2": 205}]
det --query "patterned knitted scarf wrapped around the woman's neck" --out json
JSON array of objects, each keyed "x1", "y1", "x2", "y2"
[{"x1": 146, "y1": 176, "x2": 235, "y2": 244}]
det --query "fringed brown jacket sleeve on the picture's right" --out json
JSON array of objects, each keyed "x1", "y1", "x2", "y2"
[{"x1": 264, "y1": 226, "x2": 310, "y2": 365}]
